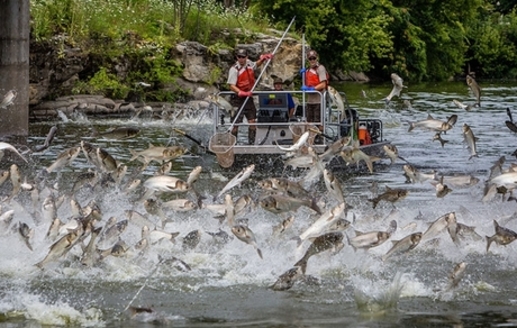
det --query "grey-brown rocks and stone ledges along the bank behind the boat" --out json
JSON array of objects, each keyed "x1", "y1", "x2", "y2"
[{"x1": 29, "y1": 30, "x2": 368, "y2": 119}]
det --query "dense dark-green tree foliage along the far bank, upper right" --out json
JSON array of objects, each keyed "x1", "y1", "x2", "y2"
[{"x1": 256, "y1": 0, "x2": 517, "y2": 81}]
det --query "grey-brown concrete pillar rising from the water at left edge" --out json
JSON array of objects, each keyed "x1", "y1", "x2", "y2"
[{"x1": 0, "y1": 0, "x2": 30, "y2": 137}]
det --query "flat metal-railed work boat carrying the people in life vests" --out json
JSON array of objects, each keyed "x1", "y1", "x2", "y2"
[{"x1": 209, "y1": 90, "x2": 389, "y2": 169}]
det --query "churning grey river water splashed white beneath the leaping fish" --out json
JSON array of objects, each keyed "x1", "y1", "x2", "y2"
[{"x1": 0, "y1": 82, "x2": 517, "y2": 327}]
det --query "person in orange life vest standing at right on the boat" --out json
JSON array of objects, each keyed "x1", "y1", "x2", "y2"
[{"x1": 301, "y1": 50, "x2": 328, "y2": 135}]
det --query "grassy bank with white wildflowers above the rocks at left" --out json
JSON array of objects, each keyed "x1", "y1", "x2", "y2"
[{"x1": 31, "y1": 0, "x2": 273, "y2": 101}]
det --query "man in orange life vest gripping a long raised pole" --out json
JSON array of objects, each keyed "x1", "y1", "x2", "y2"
[{"x1": 227, "y1": 48, "x2": 273, "y2": 145}]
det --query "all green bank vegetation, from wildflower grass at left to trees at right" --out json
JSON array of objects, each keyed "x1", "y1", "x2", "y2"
[{"x1": 31, "y1": 0, "x2": 517, "y2": 100}]
